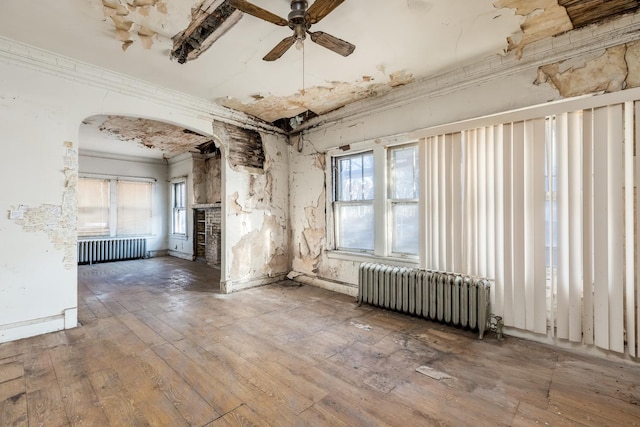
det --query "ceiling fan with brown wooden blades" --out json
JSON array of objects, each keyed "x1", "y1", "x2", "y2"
[{"x1": 228, "y1": 0, "x2": 356, "y2": 61}]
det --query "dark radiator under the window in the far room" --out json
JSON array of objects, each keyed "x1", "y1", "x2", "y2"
[{"x1": 78, "y1": 237, "x2": 147, "y2": 264}]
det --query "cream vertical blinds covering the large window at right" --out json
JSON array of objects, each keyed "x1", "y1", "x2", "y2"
[{"x1": 420, "y1": 103, "x2": 640, "y2": 356}]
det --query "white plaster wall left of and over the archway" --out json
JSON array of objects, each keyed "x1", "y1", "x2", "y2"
[{"x1": 0, "y1": 41, "x2": 222, "y2": 342}]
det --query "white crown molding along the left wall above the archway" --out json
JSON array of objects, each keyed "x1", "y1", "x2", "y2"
[{"x1": 0, "y1": 36, "x2": 284, "y2": 135}]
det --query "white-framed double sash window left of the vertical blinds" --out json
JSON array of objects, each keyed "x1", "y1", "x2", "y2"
[{"x1": 332, "y1": 143, "x2": 420, "y2": 262}]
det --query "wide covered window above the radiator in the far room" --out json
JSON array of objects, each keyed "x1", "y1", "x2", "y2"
[{"x1": 78, "y1": 177, "x2": 152, "y2": 237}]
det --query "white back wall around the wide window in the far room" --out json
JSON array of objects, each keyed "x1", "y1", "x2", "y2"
[{"x1": 79, "y1": 152, "x2": 169, "y2": 256}]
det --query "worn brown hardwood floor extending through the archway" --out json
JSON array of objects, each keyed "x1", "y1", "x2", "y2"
[{"x1": 0, "y1": 258, "x2": 640, "y2": 426}]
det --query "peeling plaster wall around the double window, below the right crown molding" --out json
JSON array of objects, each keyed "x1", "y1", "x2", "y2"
[{"x1": 290, "y1": 8, "x2": 640, "y2": 293}]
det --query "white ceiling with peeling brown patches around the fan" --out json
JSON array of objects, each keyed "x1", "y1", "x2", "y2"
[{"x1": 0, "y1": 0, "x2": 637, "y2": 159}]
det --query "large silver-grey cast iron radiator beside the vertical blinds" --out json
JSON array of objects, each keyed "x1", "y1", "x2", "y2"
[{"x1": 358, "y1": 263, "x2": 491, "y2": 339}]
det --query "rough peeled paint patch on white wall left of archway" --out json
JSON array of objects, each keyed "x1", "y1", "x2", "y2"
[{"x1": 9, "y1": 141, "x2": 78, "y2": 270}]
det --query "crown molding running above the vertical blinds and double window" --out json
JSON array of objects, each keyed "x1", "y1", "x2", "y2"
[{"x1": 292, "y1": 13, "x2": 640, "y2": 135}]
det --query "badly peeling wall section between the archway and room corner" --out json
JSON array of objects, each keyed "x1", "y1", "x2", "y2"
[{"x1": 214, "y1": 122, "x2": 290, "y2": 293}]
